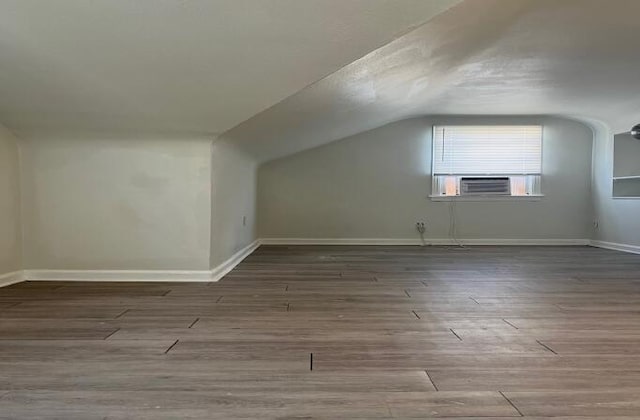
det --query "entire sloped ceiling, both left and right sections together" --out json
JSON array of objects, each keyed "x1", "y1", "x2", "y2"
[{"x1": 5, "y1": 0, "x2": 640, "y2": 161}]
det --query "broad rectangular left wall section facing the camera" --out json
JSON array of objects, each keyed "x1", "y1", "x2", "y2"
[{"x1": 21, "y1": 133, "x2": 211, "y2": 270}]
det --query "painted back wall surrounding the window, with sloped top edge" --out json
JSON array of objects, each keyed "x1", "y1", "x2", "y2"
[{"x1": 258, "y1": 117, "x2": 593, "y2": 239}]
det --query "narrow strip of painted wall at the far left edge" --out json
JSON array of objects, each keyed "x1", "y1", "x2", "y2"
[{"x1": 0, "y1": 125, "x2": 22, "y2": 276}]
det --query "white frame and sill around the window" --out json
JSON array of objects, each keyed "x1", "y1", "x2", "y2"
[{"x1": 429, "y1": 124, "x2": 544, "y2": 201}]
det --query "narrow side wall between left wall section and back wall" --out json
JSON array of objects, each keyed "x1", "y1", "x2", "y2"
[{"x1": 211, "y1": 139, "x2": 257, "y2": 268}]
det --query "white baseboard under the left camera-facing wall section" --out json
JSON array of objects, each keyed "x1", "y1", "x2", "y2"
[{"x1": 24, "y1": 270, "x2": 211, "y2": 282}]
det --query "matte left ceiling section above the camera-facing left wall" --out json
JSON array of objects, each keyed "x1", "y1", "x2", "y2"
[{"x1": 0, "y1": 0, "x2": 458, "y2": 133}]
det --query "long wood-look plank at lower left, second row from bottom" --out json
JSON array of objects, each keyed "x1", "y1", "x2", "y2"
[{"x1": 0, "y1": 357, "x2": 434, "y2": 394}]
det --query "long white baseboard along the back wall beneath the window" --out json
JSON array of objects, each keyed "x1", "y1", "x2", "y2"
[{"x1": 260, "y1": 238, "x2": 591, "y2": 246}]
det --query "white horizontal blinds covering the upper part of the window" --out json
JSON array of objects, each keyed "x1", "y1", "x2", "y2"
[{"x1": 433, "y1": 125, "x2": 542, "y2": 175}]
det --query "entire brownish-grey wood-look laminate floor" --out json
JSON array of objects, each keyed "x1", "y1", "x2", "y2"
[{"x1": 0, "y1": 246, "x2": 640, "y2": 420}]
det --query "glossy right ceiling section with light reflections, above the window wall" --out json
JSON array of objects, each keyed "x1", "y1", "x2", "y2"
[{"x1": 225, "y1": 0, "x2": 640, "y2": 161}]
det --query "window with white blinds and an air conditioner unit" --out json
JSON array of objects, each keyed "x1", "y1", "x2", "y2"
[{"x1": 432, "y1": 126, "x2": 542, "y2": 197}]
